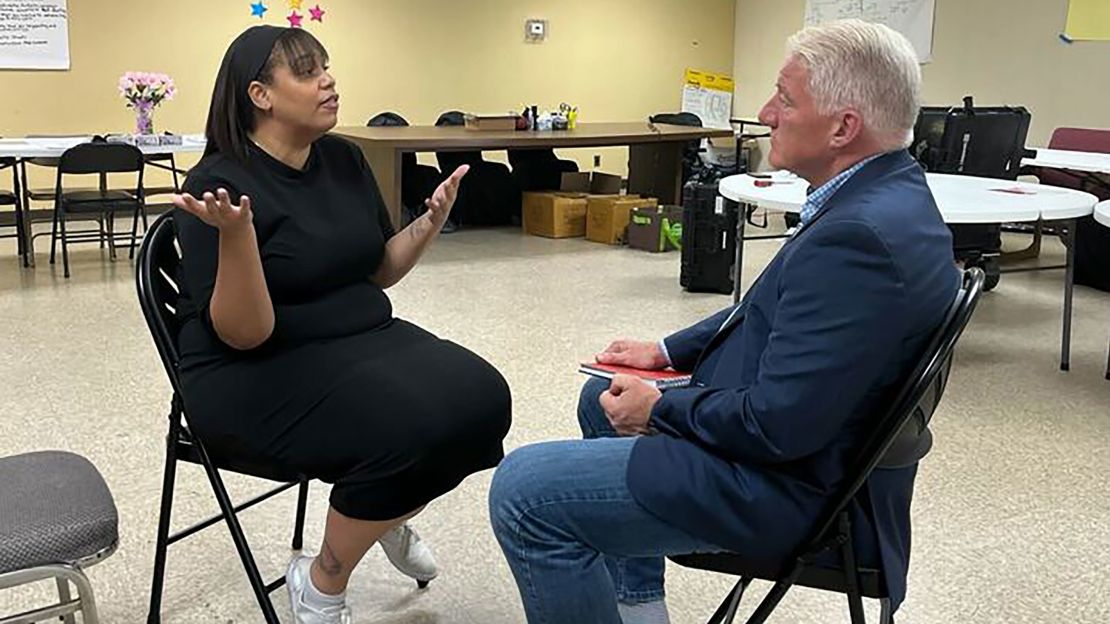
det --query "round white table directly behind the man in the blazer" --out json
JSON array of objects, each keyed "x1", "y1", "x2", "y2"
[{"x1": 719, "y1": 171, "x2": 1110, "y2": 371}]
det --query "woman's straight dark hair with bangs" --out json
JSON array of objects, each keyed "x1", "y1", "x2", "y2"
[{"x1": 204, "y1": 28, "x2": 327, "y2": 163}]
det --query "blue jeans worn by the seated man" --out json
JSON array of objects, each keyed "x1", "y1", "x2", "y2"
[{"x1": 490, "y1": 380, "x2": 722, "y2": 624}]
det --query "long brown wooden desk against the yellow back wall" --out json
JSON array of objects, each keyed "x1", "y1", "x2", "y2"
[{"x1": 332, "y1": 121, "x2": 733, "y2": 224}]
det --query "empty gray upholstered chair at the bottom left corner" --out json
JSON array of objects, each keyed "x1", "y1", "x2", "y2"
[{"x1": 0, "y1": 451, "x2": 119, "y2": 624}]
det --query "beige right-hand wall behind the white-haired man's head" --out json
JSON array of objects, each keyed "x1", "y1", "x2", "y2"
[{"x1": 734, "y1": 0, "x2": 1110, "y2": 154}]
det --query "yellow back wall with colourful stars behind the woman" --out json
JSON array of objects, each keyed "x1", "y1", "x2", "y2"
[{"x1": 0, "y1": 0, "x2": 735, "y2": 186}]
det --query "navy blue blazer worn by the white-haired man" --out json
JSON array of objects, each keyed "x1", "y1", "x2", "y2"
[{"x1": 627, "y1": 151, "x2": 960, "y2": 607}]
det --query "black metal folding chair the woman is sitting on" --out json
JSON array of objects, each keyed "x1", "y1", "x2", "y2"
[{"x1": 135, "y1": 212, "x2": 309, "y2": 624}]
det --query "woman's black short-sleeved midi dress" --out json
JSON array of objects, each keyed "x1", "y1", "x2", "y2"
[{"x1": 173, "y1": 137, "x2": 511, "y2": 520}]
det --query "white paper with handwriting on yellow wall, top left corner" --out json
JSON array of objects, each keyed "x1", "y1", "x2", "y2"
[{"x1": 0, "y1": 0, "x2": 70, "y2": 69}]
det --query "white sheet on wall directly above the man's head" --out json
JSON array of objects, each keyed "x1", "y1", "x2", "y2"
[{"x1": 806, "y1": 0, "x2": 936, "y2": 63}]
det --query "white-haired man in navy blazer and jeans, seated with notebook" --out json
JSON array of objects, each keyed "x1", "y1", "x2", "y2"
[{"x1": 490, "y1": 21, "x2": 959, "y2": 624}]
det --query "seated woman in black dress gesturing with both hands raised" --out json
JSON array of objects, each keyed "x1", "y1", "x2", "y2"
[{"x1": 174, "y1": 27, "x2": 511, "y2": 623}]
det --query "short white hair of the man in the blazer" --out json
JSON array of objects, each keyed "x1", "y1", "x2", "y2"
[{"x1": 786, "y1": 20, "x2": 921, "y2": 151}]
